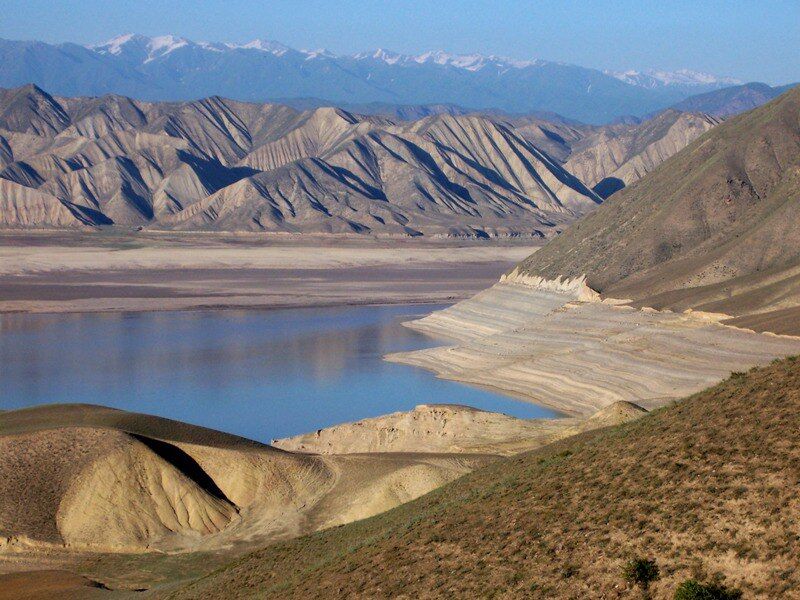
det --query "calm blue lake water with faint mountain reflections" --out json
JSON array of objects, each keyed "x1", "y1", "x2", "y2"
[{"x1": 0, "y1": 306, "x2": 554, "y2": 442}]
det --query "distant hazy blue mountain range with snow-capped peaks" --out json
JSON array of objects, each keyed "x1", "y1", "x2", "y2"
[{"x1": 0, "y1": 34, "x2": 756, "y2": 124}]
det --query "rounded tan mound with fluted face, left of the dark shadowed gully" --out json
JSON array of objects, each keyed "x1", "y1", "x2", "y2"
[{"x1": 0, "y1": 427, "x2": 237, "y2": 550}]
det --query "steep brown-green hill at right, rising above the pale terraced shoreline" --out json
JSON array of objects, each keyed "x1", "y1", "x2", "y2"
[{"x1": 521, "y1": 83, "x2": 800, "y2": 333}]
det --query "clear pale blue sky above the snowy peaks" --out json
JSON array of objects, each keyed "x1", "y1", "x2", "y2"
[{"x1": 0, "y1": 0, "x2": 800, "y2": 84}]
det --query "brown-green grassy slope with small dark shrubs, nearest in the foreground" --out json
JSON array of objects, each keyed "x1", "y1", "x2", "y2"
[{"x1": 169, "y1": 359, "x2": 800, "y2": 598}]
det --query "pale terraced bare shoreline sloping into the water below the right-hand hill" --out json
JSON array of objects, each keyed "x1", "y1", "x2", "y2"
[{"x1": 387, "y1": 269, "x2": 800, "y2": 416}]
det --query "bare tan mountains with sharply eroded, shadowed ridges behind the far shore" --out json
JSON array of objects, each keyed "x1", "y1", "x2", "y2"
[{"x1": 0, "y1": 85, "x2": 717, "y2": 237}]
